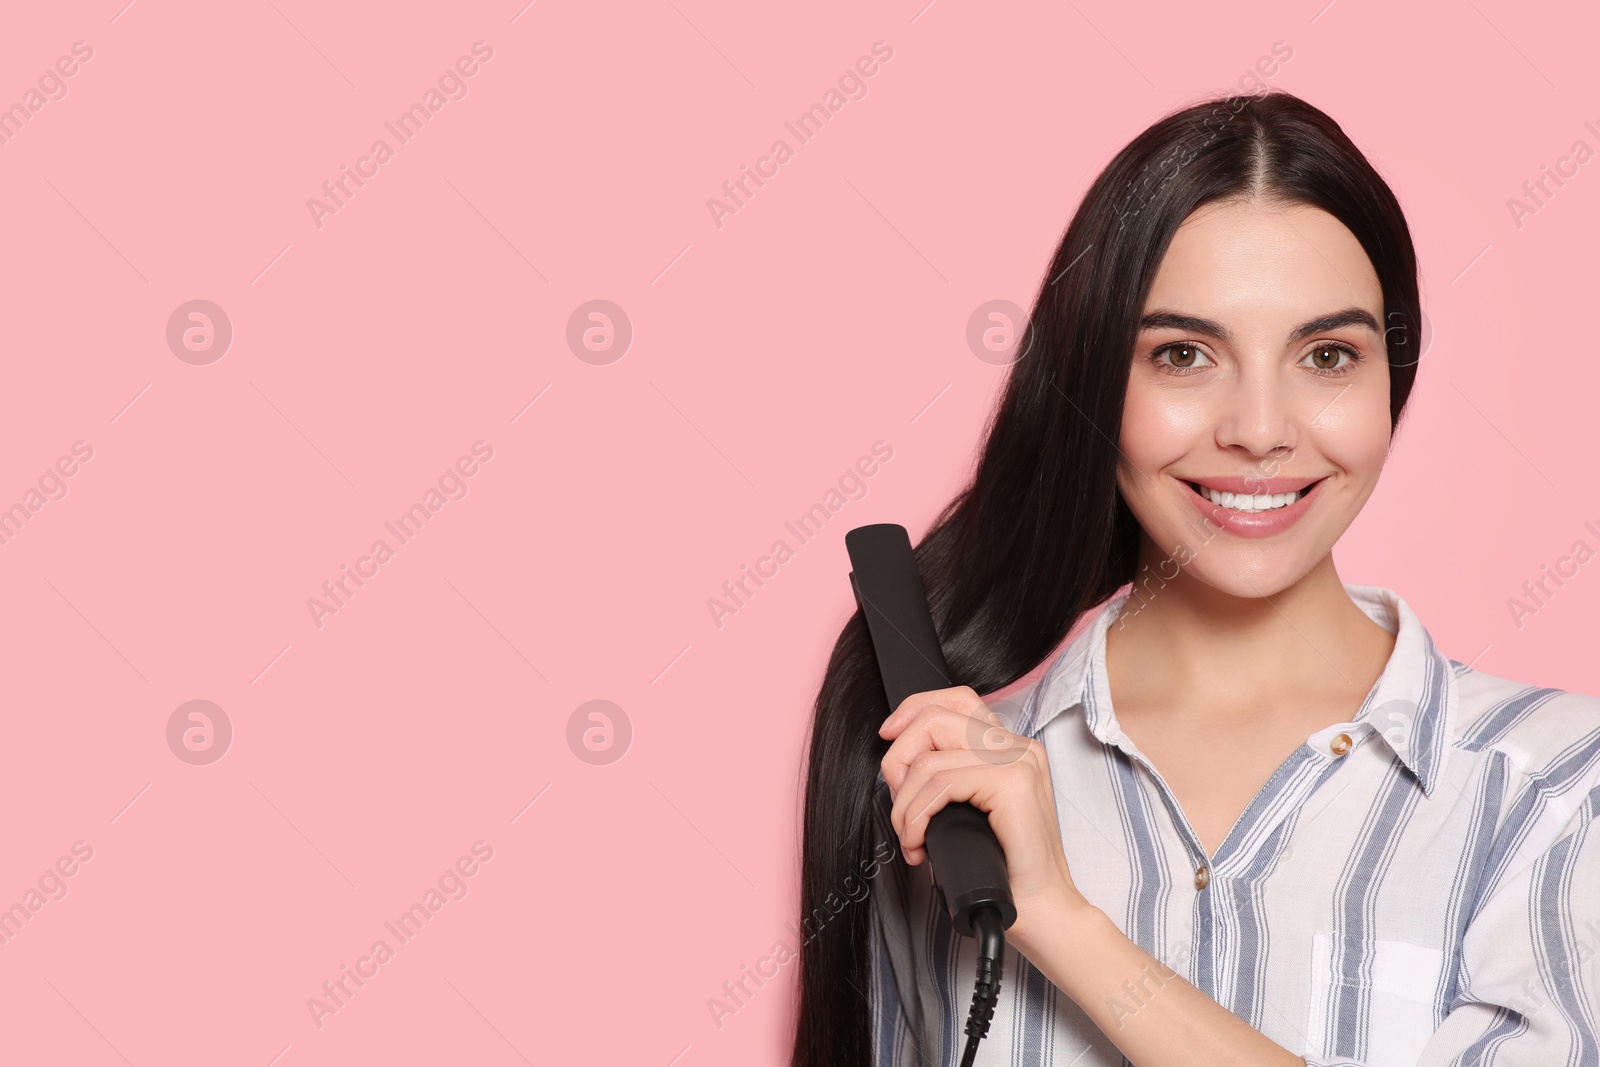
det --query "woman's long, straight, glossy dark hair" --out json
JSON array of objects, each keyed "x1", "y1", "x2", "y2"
[{"x1": 792, "y1": 91, "x2": 1422, "y2": 1067}]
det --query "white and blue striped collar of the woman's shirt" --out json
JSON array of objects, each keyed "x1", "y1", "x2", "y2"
[{"x1": 1016, "y1": 585, "x2": 1456, "y2": 797}]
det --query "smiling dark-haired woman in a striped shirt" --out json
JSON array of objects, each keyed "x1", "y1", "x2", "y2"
[{"x1": 794, "y1": 93, "x2": 1600, "y2": 1067}]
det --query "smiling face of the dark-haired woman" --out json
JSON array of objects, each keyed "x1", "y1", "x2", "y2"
[{"x1": 1117, "y1": 202, "x2": 1390, "y2": 597}]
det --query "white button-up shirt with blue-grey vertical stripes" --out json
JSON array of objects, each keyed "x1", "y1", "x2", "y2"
[{"x1": 870, "y1": 585, "x2": 1600, "y2": 1067}]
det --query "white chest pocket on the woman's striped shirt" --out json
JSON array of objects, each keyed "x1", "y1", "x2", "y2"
[{"x1": 1304, "y1": 933, "x2": 1445, "y2": 1067}]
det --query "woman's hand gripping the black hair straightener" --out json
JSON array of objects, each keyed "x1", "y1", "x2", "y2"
[{"x1": 878, "y1": 685, "x2": 1091, "y2": 955}]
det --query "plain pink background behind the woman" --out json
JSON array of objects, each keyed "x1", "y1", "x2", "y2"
[{"x1": 0, "y1": 0, "x2": 1600, "y2": 1067}]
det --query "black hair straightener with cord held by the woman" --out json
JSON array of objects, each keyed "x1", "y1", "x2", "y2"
[{"x1": 845, "y1": 523, "x2": 1016, "y2": 1067}]
